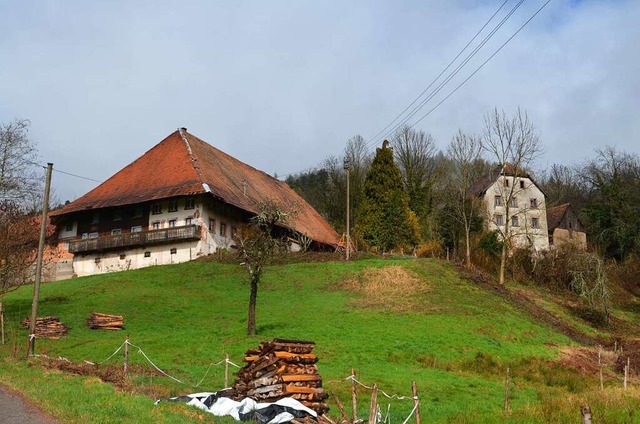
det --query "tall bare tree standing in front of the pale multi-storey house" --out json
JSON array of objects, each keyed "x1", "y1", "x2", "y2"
[{"x1": 482, "y1": 108, "x2": 542, "y2": 285}]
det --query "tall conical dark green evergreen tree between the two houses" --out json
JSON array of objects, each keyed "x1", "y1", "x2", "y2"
[{"x1": 359, "y1": 140, "x2": 419, "y2": 251}]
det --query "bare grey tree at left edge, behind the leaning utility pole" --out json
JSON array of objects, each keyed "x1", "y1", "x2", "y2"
[{"x1": 0, "y1": 119, "x2": 43, "y2": 211}]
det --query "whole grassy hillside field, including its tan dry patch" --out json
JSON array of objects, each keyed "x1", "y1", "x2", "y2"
[{"x1": 0, "y1": 259, "x2": 640, "y2": 423}]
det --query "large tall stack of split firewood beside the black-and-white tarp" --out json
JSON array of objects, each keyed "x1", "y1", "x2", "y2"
[{"x1": 232, "y1": 339, "x2": 329, "y2": 415}]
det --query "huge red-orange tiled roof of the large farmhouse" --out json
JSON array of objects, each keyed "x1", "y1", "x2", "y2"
[{"x1": 51, "y1": 128, "x2": 338, "y2": 245}]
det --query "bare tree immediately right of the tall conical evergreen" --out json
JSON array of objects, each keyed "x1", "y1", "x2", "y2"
[{"x1": 391, "y1": 125, "x2": 440, "y2": 237}]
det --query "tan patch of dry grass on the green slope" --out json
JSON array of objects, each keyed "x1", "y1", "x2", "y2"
[{"x1": 340, "y1": 266, "x2": 433, "y2": 312}]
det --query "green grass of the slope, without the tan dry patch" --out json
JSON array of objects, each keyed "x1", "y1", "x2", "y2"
[{"x1": 0, "y1": 259, "x2": 637, "y2": 422}]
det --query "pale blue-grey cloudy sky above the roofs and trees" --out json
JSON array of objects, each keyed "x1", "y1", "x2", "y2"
[{"x1": 0, "y1": 0, "x2": 640, "y2": 201}]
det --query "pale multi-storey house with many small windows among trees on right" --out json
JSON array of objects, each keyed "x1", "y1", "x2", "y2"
[{"x1": 470, "y1": 164, "x2": 549, "y2": 251}]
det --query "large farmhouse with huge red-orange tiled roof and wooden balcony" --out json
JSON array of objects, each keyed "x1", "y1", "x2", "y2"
[{"x1": 51, "y1": 128, "x2": 338, "y2": 276}]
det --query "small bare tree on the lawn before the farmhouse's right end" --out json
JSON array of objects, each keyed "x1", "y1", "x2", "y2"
[{"x1": 234, "y1": 202, "x2": 289, "y2": 336}]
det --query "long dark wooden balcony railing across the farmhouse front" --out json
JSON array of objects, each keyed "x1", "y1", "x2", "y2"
[{"x1": 69, "y1": 225, "x2": 200, "y2": 253}]
